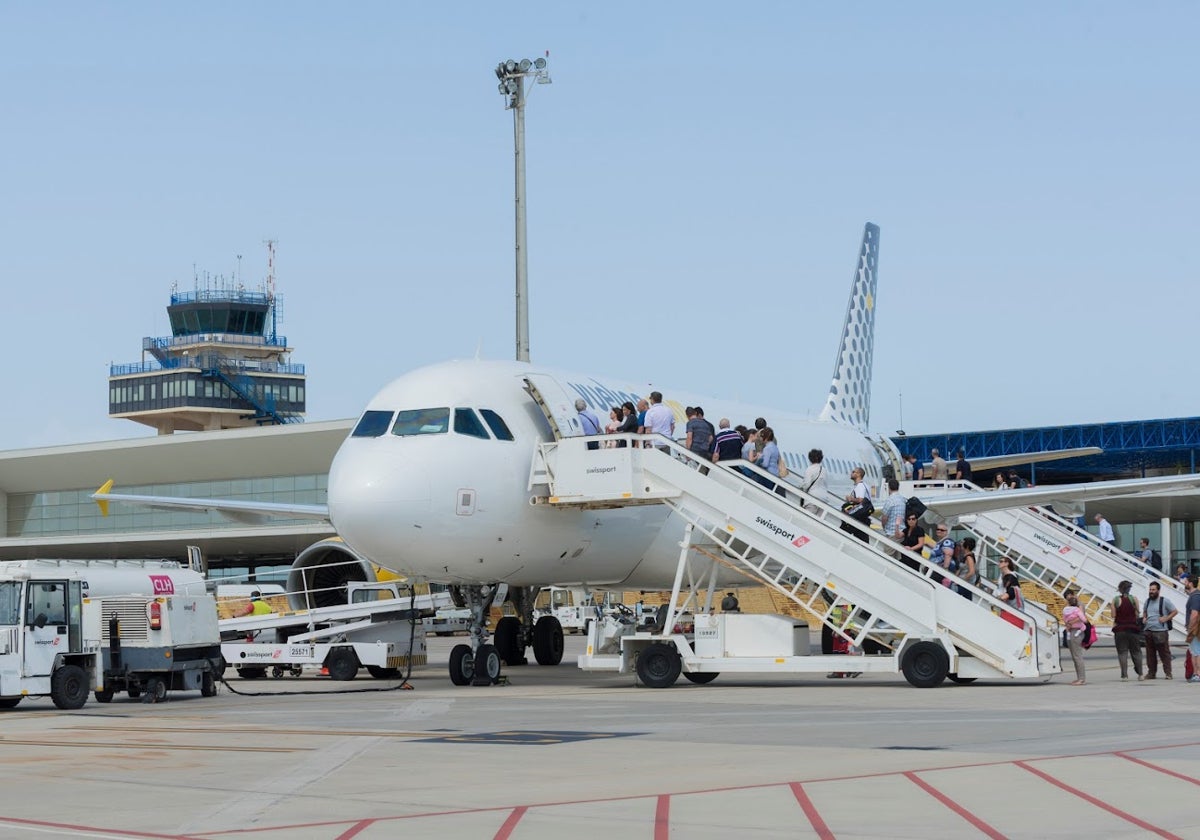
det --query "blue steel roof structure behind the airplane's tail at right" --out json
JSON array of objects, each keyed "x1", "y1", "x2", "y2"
[{"x1": 892, "y1": 418, "x2": 1200, "y2": 485}]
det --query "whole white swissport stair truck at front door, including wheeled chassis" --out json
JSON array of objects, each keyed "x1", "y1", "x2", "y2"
[{"x1": 529, "y1": 436, "x2": 1061, "y2": 688}]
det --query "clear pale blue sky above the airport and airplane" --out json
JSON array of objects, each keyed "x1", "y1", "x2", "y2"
[{"x1": 0, "y1": 2, "x2": 1200, "y2": 449}]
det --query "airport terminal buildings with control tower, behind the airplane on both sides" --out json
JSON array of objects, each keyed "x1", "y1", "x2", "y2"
[{"x1": 0, "y1": 276, "x2": 1200, "y2": 582}]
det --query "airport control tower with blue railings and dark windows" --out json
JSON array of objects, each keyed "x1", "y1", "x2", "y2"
[{"x1": 108, "y1": 241, "x2": 305, "y2": 434}]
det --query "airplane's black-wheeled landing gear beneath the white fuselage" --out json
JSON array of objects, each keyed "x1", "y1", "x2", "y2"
[{"x1": 450, "y1": 584, "x2": 563, "y2": 685}]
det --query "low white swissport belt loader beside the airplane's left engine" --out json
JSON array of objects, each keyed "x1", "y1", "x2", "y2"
[{"x1": 220, "y1": 583, "x2": 440, "y2": 679}]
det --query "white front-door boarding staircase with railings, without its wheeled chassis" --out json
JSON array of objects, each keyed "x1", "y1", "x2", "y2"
[{"x1": 529, "y1": 434, "x2": 1060, "y2": 677}]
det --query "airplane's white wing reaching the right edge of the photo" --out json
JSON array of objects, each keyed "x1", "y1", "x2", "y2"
[{"x1": 912, "y1": 474, "x2": 1200, "y2": 518}]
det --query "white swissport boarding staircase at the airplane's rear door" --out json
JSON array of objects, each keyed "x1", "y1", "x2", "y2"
[{"x1": 900, "y1": 481, "x2": 1188, "y2": 643}]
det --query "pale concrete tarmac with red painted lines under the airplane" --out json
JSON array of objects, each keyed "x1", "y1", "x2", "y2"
[{"x1": 0, "y1": 636, "x2": 1200, "y2": 840}]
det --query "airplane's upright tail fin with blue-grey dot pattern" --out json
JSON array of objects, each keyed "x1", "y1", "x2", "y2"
[{"x1": 821, "y1": 222, "x2": 880, "y2": 432}]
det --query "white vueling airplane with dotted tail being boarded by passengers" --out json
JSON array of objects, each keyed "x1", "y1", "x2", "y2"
[{"x1": 94, "y1": 223, "x2": 1196, "y2": 684}]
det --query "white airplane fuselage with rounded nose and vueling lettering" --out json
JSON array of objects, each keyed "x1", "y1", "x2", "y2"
[{"x1": 329, "y1": 361, "x2": 894, "y2": 589}]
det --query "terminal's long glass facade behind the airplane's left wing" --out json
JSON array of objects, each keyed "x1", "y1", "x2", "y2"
[{"x1": 6, "y1": 474, "x2": 329, "y2": 538}]
